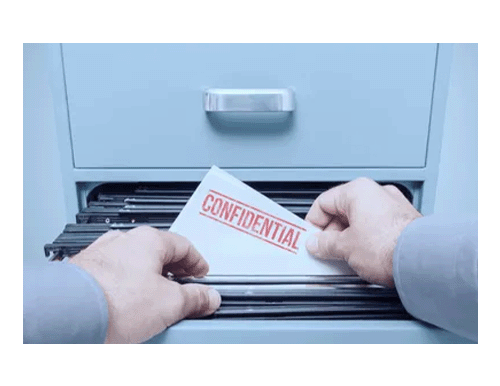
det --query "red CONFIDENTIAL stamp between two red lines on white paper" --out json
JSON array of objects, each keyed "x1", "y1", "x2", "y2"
[{"x1": 200, "y1": 190, "x2": 306, "y2": 254}]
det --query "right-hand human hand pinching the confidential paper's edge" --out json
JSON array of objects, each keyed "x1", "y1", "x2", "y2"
[{"x1": 306, "y1": 178, "x2": 422, "y2": 287}]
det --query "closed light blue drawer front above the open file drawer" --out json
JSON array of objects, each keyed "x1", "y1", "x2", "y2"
[{"x1": 62, "y1": 43, "x2": 437, "y2": 168}]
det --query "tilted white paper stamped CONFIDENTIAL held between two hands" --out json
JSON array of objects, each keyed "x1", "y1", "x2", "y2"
[{"x1": 170, "y1": 166, "x2": 355, "y2": 275}]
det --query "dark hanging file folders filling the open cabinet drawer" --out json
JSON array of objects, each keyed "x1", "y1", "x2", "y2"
[{"x1": 45, "y1": 182, "x2": 413, "y2": 320}]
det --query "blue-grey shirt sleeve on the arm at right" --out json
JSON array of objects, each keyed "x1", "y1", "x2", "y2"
[{"x1": 393, "y1": 215, "x2": 478, "y2": 342}]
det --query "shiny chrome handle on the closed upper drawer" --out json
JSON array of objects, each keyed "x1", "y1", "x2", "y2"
[{"x1": 203, "y1": 88, "x2": 295, "y2": 112}]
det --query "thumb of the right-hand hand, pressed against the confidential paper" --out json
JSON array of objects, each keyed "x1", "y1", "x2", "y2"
[{"x1": 306, "y1": 230, "x2": 348, "y2": 260}]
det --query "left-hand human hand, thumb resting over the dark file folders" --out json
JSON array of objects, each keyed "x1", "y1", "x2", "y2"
[{"x1": 70, "y1": 226, "x2": 221, "y2": 343}]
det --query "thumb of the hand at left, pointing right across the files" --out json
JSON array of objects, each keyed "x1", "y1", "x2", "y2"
[{"x1": 176, "y1": 284, "x2": 221, "y2": 320}]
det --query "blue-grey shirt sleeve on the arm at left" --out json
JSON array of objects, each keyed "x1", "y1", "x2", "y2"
[{"x1": 23, "y1": 262, "x2": 108, "y2": 344}]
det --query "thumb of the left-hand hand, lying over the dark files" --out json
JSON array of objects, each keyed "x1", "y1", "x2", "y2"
[{"x1": 166, "y1": 282, "x2": 221, "y2": 323}]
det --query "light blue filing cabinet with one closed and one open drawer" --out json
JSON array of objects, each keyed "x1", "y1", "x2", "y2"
[{"x1": 45, "y1": 43, "x2": 467, "y2": 343}]
